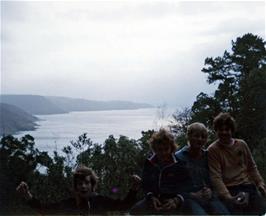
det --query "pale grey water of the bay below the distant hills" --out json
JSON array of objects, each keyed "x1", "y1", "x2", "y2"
[{"x1": 17, "y1": 108, "x2": 175, "y2": 152}]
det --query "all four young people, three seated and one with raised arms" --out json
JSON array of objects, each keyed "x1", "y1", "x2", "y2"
[{"x1": 17, "y1": 113, "x2": 266, "y2": 215}]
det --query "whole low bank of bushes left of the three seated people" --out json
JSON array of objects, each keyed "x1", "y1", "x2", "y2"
[{"x1": 0, "y1": 131, "x2": 153, "y2": 214}]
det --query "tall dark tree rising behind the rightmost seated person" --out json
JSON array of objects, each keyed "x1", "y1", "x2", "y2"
[{"x1": 191, "y1": 33, "x2": 266, "y2": 150}]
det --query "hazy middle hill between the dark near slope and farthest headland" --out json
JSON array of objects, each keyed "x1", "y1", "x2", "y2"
[{"x1": 0, "y1": 95, "x2": 66, "y2": 115}]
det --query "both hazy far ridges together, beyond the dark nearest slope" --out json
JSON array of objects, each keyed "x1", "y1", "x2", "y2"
[{"x1": 0, "y1": 95, "x2": 152, "y2": 115}]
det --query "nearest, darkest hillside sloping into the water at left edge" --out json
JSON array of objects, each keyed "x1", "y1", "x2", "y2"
[{"x1": 0, "y1": 103, "x2": 38, "y2": 136}]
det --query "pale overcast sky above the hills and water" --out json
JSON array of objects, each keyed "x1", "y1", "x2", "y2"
[{"x1": 1, "y1": 1, "x2": 265, "y2": 107}]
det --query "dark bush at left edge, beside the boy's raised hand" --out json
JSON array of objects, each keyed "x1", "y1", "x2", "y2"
[{"x1": 0, "y1": 135, "x2": 38, "y2": 213}]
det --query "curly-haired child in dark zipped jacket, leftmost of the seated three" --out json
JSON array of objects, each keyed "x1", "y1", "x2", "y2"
[{"x1": 130, "y1": 129, "x2": 186, "y2": 215}]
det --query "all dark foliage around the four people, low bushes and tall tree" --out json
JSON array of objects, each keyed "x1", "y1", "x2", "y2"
[{"x1": 0, "y1": 34, "x2": 266, "y2": 214}]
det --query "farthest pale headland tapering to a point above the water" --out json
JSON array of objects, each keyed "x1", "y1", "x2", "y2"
[{"x1": 46, "y1": 97, "x2": 152, "y2": 111}]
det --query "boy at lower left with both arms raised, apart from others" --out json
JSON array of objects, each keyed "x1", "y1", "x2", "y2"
[{"x1": 17, "y1": 166, "x2": 140, "y2": 216}]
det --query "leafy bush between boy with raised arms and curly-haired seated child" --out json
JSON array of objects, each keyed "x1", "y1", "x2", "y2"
[{"x1": 71, "y1": 131, "x2": 153, "y2": 198}]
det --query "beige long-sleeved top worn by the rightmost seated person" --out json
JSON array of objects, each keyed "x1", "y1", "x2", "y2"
[{"x1": 208, "y1": 139, "x2": 264, "y2": 199}]
